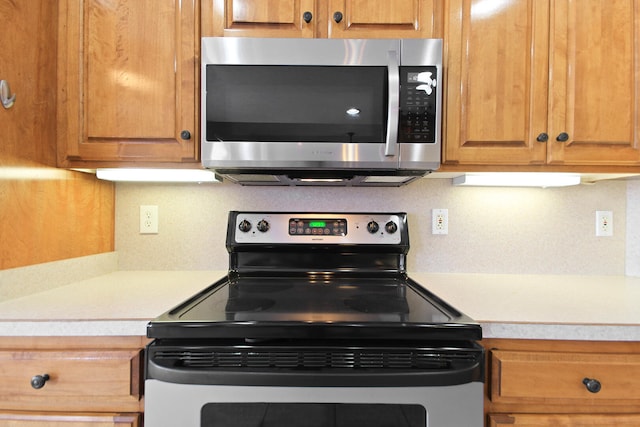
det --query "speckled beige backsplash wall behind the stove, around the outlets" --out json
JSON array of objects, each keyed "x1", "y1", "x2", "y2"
[{"x1": 116, "y1": 179, "x2": 624, "y2": 275}]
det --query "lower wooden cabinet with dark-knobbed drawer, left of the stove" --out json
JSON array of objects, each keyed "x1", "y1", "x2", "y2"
[{"x1": 0, "y1": 337, "x2": 147, "y2": 427}]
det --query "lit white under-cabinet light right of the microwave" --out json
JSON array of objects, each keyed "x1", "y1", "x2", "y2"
[{"x1": 453, "y1": 172, "x2": 580, "y2": 188}]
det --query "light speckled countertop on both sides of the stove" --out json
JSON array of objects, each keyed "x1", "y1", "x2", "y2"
[{"x1": 0, "y1": 271, "x2": 640, "y2": 341}]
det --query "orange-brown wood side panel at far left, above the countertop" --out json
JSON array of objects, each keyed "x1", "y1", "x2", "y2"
[{"x1": 0, "y1": 0, "x2": 115, "y2": 269}]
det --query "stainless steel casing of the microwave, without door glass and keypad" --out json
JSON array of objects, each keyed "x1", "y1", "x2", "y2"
[{"x1": 201, "y1": 37, "x2": 443, "y2": 186}]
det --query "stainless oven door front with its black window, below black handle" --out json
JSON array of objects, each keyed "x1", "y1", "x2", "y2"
[{"x1": 145, "y1": 380, "x2": 483, "y2": 427}]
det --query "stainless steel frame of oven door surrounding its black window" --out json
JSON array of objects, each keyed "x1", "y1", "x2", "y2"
[{"x1": 145, "y1": 380, "x2": 484, "y2": 427}]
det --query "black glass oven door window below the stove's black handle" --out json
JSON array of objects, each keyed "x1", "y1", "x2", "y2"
[{"x1": 201, "y1": 403, "x2": 427, "y2": 427}]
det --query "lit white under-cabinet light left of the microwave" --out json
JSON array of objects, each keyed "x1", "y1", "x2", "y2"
[{"x1": 96, "y1": 168, "x2": 222, "y2": 182}]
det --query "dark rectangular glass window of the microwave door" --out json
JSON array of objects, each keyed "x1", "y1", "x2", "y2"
[{"x1": 206, "y1": 65, "x2": 388, "y2": 143}]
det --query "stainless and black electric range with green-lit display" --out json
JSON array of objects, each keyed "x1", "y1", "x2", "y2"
[{"x1": 145, "y1": 211, "x2": 484, "y2": 427}]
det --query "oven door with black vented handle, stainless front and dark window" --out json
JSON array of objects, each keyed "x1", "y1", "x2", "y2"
[{"x1": 145, "y1": 340, "x2": 484, "y2": 427}]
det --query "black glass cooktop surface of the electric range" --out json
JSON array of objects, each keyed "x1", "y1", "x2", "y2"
[{"x1": 147, "y1": 273, "x2": 481, "y2": 340}]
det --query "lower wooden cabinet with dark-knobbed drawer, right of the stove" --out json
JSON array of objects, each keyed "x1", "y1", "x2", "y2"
[{"x1": 483, "y1": 339, "x2": 640, "y2": 427}]
